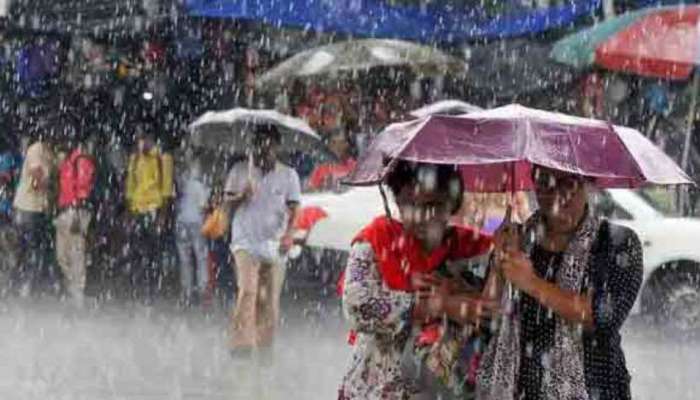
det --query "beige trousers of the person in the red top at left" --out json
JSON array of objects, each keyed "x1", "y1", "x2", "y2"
[{"x1": 55, "y1": 208, "x2": 92, "y2": 299}]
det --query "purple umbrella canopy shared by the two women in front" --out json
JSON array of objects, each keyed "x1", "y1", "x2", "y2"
[{"x1": 347, "y1": 104, "x2": 693, "y2": 192}]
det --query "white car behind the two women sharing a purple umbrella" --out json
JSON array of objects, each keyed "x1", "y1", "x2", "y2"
[{"x1": 303, "y1": 187, "x2": 700, "y2": 331}]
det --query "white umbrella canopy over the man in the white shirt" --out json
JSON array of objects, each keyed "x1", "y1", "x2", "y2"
[{"x1": 190, "y1": 108, "x2": 323, "y2": 152}]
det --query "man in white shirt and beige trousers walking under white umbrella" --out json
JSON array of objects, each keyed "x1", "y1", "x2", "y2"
[{"x1": 224, "y1": 125, "x2": 301, "y2": 354}]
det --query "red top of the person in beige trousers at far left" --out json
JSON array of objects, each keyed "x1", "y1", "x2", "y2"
[{"x1": 58, "y1": 149, "x2": 95, "y2": 208}]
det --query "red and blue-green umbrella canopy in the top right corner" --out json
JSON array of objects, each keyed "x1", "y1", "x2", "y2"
[{"x1": 550, "y1": 5, "x2": 700, "y2": 80}]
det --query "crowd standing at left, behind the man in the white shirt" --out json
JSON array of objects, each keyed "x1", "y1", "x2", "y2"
[{"x1": 0, "y1": 114, "x2": 230, "y2": 305}]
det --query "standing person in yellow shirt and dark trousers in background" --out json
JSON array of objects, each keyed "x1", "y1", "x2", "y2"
[{"x1": 126, "y1": 133, "x2": 174, "y2": 301}]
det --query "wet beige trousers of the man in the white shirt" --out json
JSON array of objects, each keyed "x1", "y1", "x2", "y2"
[{"x1": 229, "y1": 251, "x2": 285, "y2": 349}]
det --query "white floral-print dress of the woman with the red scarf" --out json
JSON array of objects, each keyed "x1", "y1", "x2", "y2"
[{"x1": 338, "y1": 242, "x2": 418, "y2": 400}]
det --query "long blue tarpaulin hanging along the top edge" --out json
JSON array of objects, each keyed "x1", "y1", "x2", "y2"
[{"x1": 185, "y1": 0, "x2": 601, "y2": 42}]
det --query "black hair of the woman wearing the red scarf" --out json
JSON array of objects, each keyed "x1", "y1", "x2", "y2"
[{"x1": 384, "y1": 160, "x2": 464, "y2": 214}]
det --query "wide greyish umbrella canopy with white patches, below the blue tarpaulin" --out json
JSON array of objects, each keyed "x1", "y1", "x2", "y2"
[{"x1": 258, "y1": 39, "x2": 464, "y2": 85}]
